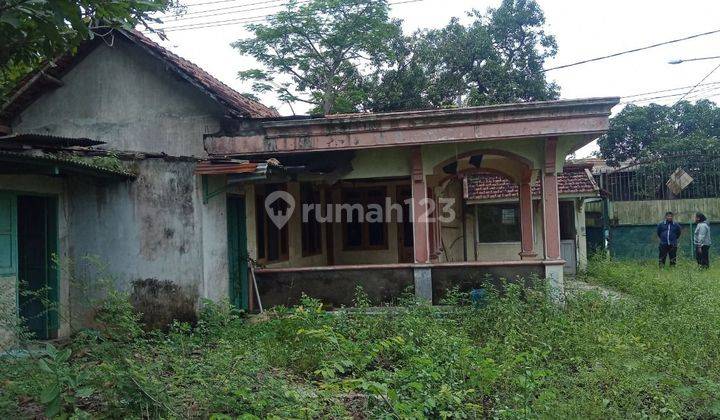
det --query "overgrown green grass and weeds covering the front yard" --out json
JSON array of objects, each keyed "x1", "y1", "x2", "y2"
[{"x1": 0, "y1": 261, "x2": 720, "y2": 418}]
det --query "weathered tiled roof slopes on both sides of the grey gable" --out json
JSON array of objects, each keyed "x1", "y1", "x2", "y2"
[{"x1": 0, "y1": 29, "x2": 279, "y2": 123}]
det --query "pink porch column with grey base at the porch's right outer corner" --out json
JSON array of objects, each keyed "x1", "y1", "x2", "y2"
[{"x1": 541, "y1": 137, "x2": 565, "y2": 305}]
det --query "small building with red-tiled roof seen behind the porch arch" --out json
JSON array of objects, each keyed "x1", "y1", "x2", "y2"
[{"x1": 463, "y1": 163, "x2": 600, "y2": 275}]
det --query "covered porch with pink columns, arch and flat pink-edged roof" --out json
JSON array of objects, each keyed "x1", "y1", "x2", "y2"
[{"x1": 198, "y1": 98, "x2": 617, "y2": 308}]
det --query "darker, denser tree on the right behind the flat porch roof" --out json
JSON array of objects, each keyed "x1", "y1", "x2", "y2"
[{"x1": 368, "y1": 0, "x2": 558, "y2": 111}]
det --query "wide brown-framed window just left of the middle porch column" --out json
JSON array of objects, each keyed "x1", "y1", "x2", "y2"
[{"x1": 341, "y1": 187, "x2": 388, "y2": 250}]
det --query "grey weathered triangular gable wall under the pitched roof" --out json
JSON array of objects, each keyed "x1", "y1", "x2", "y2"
[{"x1": 12, "y1": 37, "x2": 222, "y2": 156}]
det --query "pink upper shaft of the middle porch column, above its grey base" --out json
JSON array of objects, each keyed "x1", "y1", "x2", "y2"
[{"x1": 410, "y1": 146, "x2": 430, "y2": 263}]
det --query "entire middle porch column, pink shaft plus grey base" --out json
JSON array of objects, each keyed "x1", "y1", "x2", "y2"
[{"x1": 410, "y1": 146, "x2": 432, "y2": 302}]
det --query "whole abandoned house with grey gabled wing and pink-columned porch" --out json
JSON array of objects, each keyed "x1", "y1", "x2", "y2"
[{"x1": 0, "y1": 31, "x2": 618, "y2": 340}]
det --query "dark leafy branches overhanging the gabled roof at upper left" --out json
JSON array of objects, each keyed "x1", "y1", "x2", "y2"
[{"x1": 0, "y1": 0, "x2": 177, "y2": 101}]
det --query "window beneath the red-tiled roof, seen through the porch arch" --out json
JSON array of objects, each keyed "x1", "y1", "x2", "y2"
[{"x1": 477, "y1": 203, "x2": 520, "y2": 243}]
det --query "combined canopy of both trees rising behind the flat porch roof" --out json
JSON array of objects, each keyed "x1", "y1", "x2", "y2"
[{"x1": 234, "y1": 0, "x2": 558, "y2": 114}]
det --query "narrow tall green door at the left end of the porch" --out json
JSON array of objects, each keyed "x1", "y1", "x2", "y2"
[{"x1": 227, "y1": 195, "x2": 250, "y2": 309}]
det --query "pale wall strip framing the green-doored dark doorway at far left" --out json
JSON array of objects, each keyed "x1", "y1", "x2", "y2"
[{"x1": 0, "y1": 175, "x2": 71, "y2": 344}]
